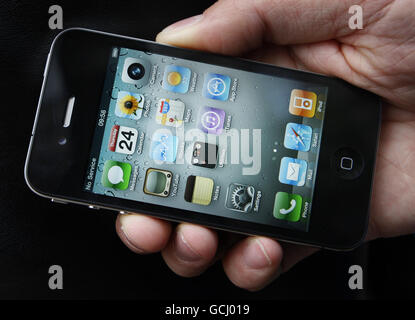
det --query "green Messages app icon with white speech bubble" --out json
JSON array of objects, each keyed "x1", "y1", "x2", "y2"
[{"x1": 101, "y1": 160, "x2": 131, "y2": 190}]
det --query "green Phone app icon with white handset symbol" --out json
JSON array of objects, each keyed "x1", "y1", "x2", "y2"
[{"x1": 273, "y1": 192, "x2": 303, "y2": 222}]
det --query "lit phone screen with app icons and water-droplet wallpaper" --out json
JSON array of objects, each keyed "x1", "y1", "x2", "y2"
[{"x1": 83, "y1": 47, "x2": 327, "y2": 231}]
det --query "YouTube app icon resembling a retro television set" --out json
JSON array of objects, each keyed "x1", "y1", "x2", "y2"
[{"x1": 144, "y1": 168, "x2": 173, "y2": 197}]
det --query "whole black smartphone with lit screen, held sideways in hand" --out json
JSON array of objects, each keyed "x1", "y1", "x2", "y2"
[{"x1": 25, "y1": 29, "x2": 381, "y2": 250}]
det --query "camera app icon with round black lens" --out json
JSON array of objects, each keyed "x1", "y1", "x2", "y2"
[{"x1": 121, "y1": 57, "x2": 151, "y2": 86}]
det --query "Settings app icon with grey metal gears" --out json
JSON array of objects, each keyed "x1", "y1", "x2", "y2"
[{"x1": 225, "y1": 183, "x2": 255, "y2": 212}]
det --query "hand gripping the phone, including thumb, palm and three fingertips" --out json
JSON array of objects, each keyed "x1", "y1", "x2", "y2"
[{"x1": 116, "y1": 0, "x2": 415, "y2": 291}]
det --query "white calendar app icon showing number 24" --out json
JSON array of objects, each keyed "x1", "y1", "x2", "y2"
[{"x1": 108, "y1": 125, "x2": 138, "y2": 154}]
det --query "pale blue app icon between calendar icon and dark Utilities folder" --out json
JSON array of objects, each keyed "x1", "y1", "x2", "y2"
[{"x1": 150, "y1": 130, "x2": 178, "y2": 162}]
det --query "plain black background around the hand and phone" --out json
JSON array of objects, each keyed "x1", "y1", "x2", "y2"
[{"x1": 0, "y1": 0, "x2": 415, "y2": 299}]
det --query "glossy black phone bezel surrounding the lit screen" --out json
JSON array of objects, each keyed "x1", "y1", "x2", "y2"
[{"x1": 25, "y1": 28, "x2": 381, "y2": 250}]
